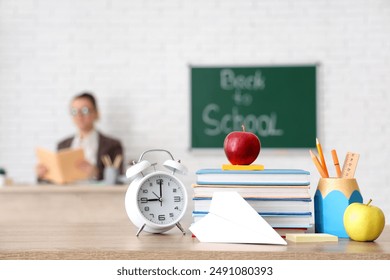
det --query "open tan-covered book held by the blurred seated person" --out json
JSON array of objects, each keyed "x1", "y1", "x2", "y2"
[{"x1": 36, "y1": 148, "x2": 88, "y2": 184}]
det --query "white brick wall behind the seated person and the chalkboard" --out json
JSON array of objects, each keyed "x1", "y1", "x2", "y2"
[{"x1": 0, "y1": 0, "x2": 390, "y2": 217}]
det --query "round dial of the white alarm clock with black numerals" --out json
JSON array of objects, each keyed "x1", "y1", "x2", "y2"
[{"x1": 137, "y1": 172, "x2": 187, "y2": 226}]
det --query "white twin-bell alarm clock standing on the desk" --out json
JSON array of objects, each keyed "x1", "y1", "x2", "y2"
[{"x1": 125, "y1": 149, "x2": 187, "y2": 236}]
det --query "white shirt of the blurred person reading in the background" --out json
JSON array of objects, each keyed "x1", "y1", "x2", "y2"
[{"x1": 72, "y1": 130, "x2": 99, "y2": 166}]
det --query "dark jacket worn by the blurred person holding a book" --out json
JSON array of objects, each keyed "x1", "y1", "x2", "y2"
[{"x1": 57, "y1": 132, "x2": 124, "y2": 180}]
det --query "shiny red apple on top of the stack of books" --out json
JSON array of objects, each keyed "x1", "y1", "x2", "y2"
[{"x1": 223, "y1": 125, "x2": 261, "y2": 165}]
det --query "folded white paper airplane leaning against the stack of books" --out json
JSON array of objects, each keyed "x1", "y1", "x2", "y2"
[{"x1": 190, "y1": 192, "x2": 287, "y2": 245}]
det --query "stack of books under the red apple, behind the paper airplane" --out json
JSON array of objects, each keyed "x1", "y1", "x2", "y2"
[{"x1": 192, "y1": 169, "x2": 312, "y2": 237}]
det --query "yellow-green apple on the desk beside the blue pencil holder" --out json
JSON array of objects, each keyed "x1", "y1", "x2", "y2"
[{"x1": 344, "y1": 199, "x2": 385, "y2": 241}]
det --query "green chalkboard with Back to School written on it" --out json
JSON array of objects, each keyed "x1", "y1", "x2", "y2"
[{"x1": 190, "y1": 65, "x2": 317, "y2": 148}]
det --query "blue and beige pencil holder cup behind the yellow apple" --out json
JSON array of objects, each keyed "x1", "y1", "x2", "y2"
[{"x1": 314, "y1": 178, "x2": 363, "y2": 238}]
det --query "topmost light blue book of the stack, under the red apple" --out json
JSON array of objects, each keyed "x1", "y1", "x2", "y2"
[{"x1": 196, "y1": 169, "x2": 310, "y2": 186}]
